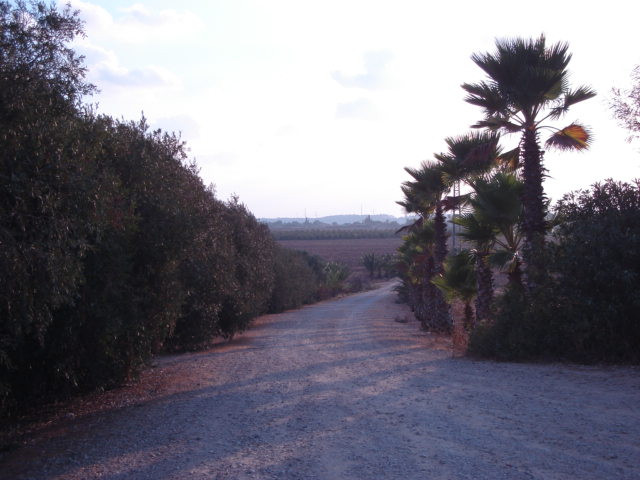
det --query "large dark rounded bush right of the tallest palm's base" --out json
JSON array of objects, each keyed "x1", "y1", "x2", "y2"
[{"x1": 469, "y1": 180, "x2": 640, "y2": 363}]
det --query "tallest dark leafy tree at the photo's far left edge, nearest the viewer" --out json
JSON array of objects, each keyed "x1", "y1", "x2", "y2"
[{"x1": 0, "y1": 1, "x2": 102, "y2": 411}]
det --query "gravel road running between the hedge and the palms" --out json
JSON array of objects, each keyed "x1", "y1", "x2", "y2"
[{"x1": 0, "y1": 284, "x2": 640, "y2": 480}]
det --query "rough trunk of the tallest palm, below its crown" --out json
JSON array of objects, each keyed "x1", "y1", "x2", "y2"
[{"x1": 522, "y1": 128, "x2": 546, "y2": 290}]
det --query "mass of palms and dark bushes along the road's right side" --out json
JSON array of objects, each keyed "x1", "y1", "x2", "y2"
[{"x1": 399, "y1": 36, "x2": 640, "y2": 363}]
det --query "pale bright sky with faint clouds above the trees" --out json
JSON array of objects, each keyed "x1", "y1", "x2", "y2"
[{"x1": 60, "y1": 0, "x2": 640, "y2": 218}]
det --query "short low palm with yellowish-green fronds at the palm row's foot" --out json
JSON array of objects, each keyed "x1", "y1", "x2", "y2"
[{"x1": 432, "y1": 250, "x2": 476, "y2": 331}]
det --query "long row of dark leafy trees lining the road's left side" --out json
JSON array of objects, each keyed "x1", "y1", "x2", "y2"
[{"x1": 0, "y1": 1, "x2": 350, "y2": 416}]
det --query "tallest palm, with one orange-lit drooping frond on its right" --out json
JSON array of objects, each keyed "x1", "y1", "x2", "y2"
[{"x1": 462, "y1": 35, "x2": 595, "y2": 288}]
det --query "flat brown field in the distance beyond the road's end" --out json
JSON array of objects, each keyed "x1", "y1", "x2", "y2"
[{"x1": 278, "y1": 237, "x2": 402, "y2": 270}]
